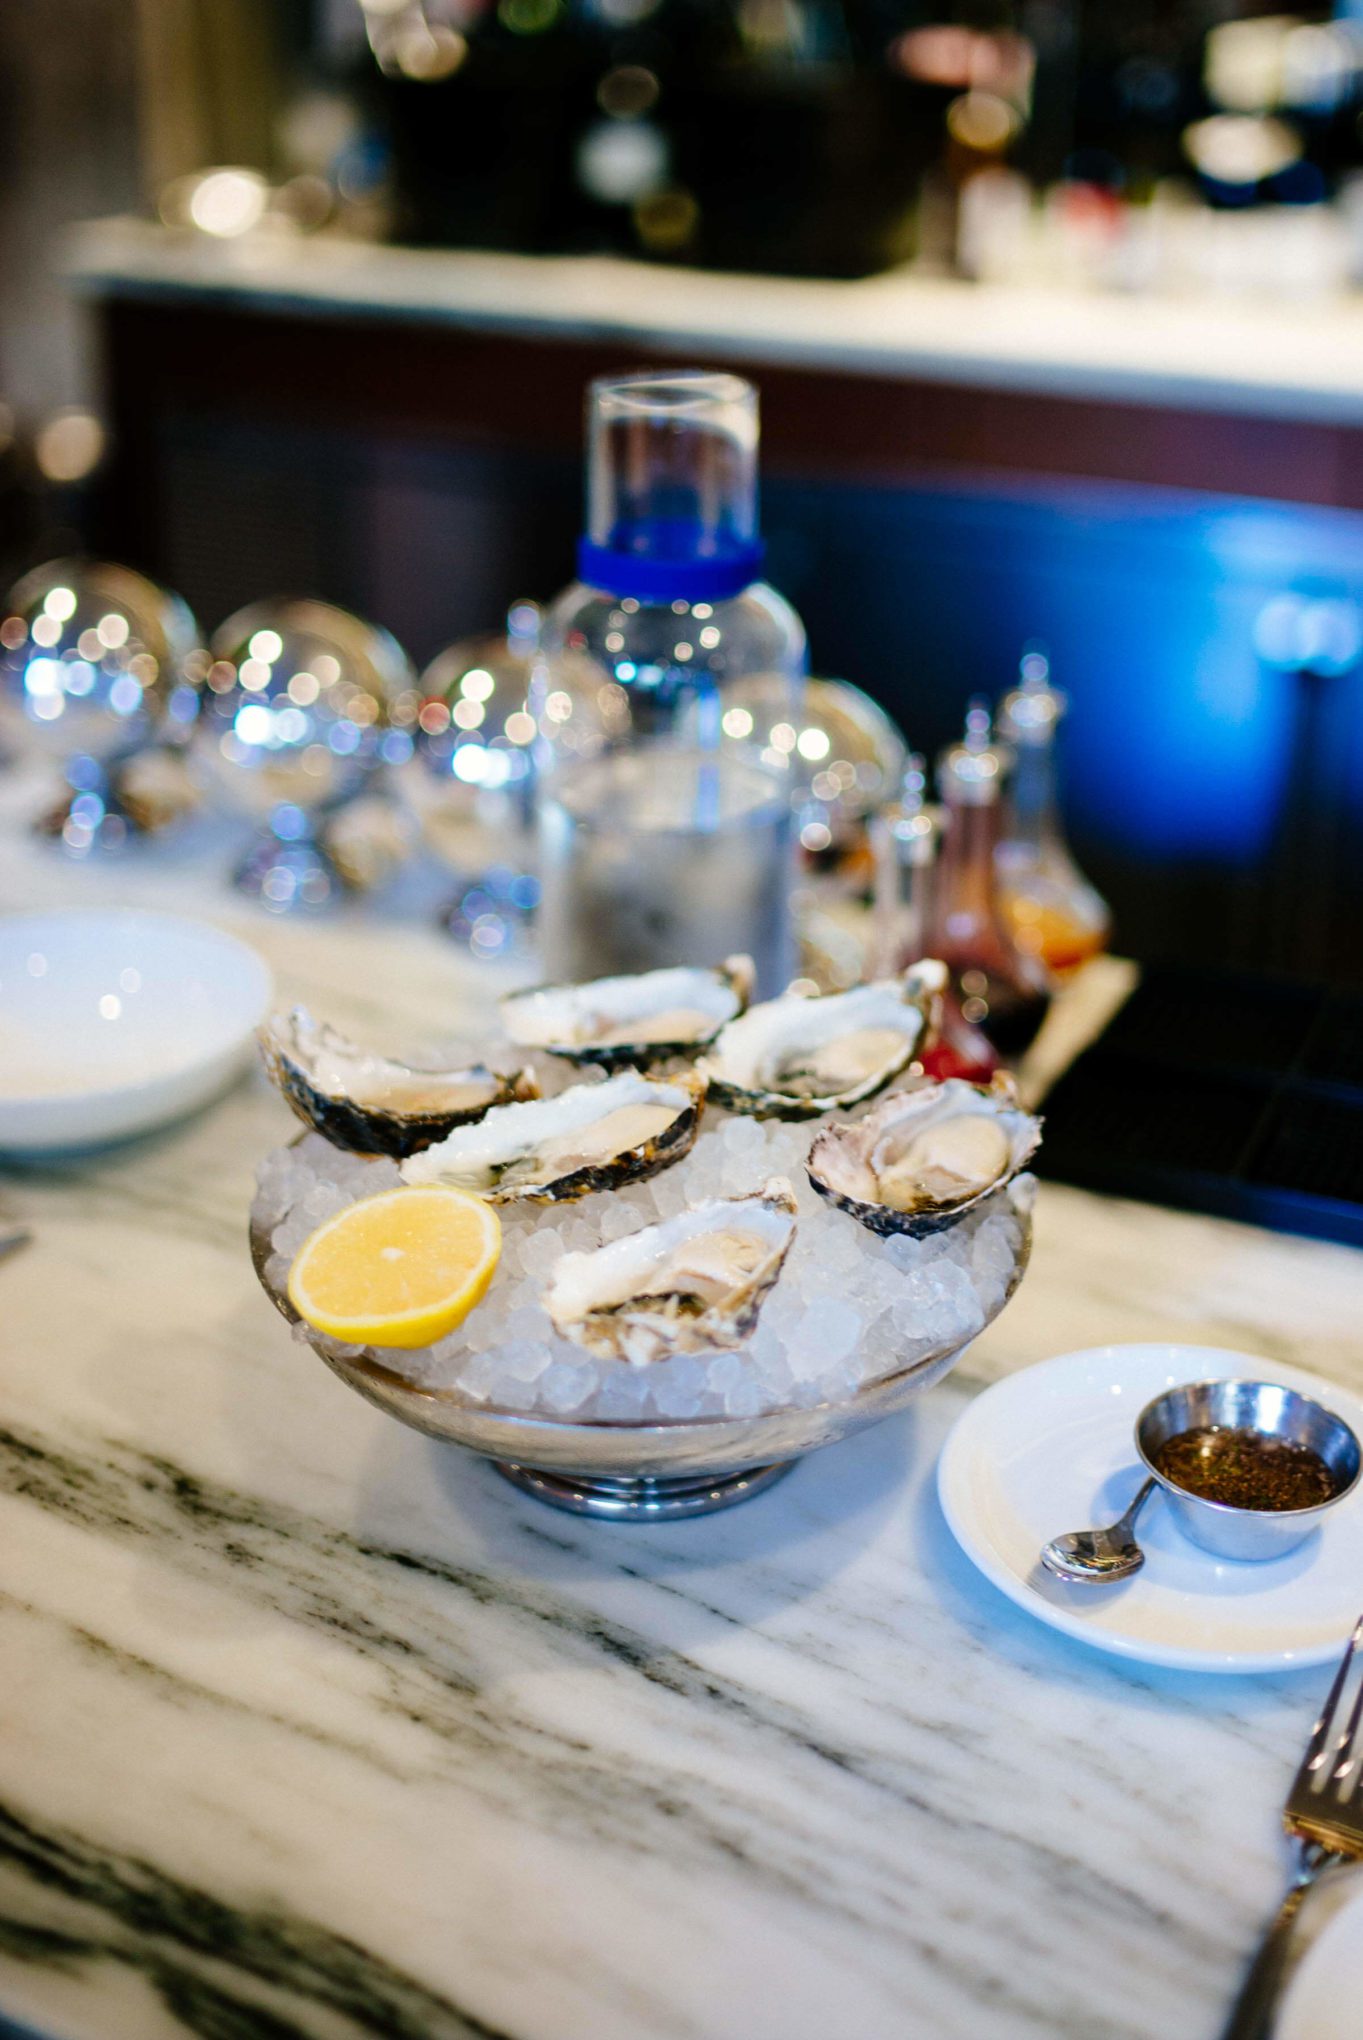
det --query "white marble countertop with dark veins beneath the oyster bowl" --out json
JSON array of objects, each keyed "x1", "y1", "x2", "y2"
[{"x1": 0, "y1": 787, "x2": 1363, "y2": 2040}]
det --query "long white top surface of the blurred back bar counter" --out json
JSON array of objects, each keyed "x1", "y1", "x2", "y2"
[{"x1": 65, "y1": 218, "x2": 1363, "y2": 424}]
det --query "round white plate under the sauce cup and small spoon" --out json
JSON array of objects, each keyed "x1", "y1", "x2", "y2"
[{"x1": 937, "y1": 1346, "x2": 1363, "y2": 1671}]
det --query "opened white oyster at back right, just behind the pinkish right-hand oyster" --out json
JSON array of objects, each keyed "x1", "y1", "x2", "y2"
[{"x1": 698, "y1": 961, "x2": 947, "y2": 1120}]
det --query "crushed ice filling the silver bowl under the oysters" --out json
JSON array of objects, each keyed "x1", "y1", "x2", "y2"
[{"x1": 253, "y1": 1116, "x2": 1034, "y2": 1424}]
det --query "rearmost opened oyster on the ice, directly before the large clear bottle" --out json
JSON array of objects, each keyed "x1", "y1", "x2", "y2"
[{"x1": 502, "y1": 957, "x2": 753, "y2": 1069}]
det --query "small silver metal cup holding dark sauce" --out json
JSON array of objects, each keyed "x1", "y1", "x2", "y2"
[{"x1": 1137, "y1": 1381, "x2": 1363, "y2": 1559}]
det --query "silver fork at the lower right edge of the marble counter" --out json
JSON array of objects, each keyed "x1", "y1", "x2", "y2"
[{"x1": 1222, "y1": 1616, "x2": 1363, "y2": 2040}]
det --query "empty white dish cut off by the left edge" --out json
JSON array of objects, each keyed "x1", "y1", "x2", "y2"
[{"x1": 0, "y1": 908, "x2": 271, "y2": 1155}]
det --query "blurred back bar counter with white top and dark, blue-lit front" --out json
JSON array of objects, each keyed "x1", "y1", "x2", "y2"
[{"x1": 65, "y1": 218, "x2": 1363, "y2": 981}]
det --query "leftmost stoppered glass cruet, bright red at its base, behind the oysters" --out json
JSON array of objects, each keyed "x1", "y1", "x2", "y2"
[{"x1": 869, "y1": 753, "x2": 998, "y2": 1083}]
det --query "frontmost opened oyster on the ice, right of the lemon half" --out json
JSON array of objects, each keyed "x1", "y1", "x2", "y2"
[{"x1": 545, "y1": 1175, "x2": 796, "y2": 1367}]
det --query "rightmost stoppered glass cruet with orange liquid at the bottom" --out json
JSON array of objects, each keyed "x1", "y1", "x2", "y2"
[{"x1": 998, "y1": 649, "x2": 1112, "y2": 977}]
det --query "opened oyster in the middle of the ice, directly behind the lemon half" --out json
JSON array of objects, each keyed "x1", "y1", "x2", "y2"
[{"x1": 402, "y1": 1069, "x2": 706, "y2": 1204}]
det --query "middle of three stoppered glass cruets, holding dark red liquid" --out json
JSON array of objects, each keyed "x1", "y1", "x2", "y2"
[{"x1": 928, "y1": 700, "x2": 1051, "y2": 1057}]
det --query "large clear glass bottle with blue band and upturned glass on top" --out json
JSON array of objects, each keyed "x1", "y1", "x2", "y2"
[{"x1": 539, "y1": 369, "x2": 806, "y2": 996}]
